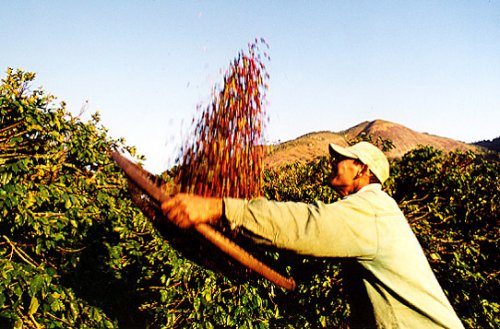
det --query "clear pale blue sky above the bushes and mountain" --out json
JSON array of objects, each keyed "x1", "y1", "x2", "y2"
[{"x1": 0, "y1": 0, "x2": 500, "y2": 172}]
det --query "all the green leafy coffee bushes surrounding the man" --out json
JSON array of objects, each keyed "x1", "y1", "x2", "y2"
[{"x1": 0, "y1": 69, "x2": 500, "y2": 328}]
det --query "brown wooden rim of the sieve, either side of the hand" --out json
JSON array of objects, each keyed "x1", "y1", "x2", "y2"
[{"x1": 111, "y1": 152, "x2": 296, "y2": 290}]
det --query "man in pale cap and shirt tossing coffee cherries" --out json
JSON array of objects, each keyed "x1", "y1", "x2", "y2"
[{"x1": 162, "y1": 142, "x2": 463, "y2": 328}]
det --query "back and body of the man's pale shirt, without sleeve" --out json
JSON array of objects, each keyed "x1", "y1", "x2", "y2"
[{"x1": 348, "y1": 188, "x2": 463, "y2": 328}]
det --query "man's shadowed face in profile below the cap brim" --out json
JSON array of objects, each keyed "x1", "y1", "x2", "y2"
[{"x1": 328, "y1": 158, "x2": 363, "y2": 196}]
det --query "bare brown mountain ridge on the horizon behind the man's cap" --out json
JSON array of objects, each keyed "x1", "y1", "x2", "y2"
[{"x1": 265, "y1": 120, "x2": 482, "y2": 167}]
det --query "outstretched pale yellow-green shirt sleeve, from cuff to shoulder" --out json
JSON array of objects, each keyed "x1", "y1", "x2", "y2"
[{"x1": 224, "y1": 198, "x2": 378, "y2": 259}]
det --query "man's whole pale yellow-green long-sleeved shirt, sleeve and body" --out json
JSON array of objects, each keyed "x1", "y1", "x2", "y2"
[{"x1": 224, "y1": 184, "x2": 463, "y2": 328}]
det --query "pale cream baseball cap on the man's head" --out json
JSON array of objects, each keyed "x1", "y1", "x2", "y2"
[{"x1": 329, "y1": 142, "x2": 389, "y2": 183}]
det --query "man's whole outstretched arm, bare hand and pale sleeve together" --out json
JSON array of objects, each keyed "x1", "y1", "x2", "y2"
[{"x1": 162, "y1": 194, "x2": 377, "y2": 259}]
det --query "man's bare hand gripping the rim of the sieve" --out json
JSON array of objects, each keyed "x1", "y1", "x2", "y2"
[{"x1": 161, "y1": 193, "x2": 223, "y2": 228}]
